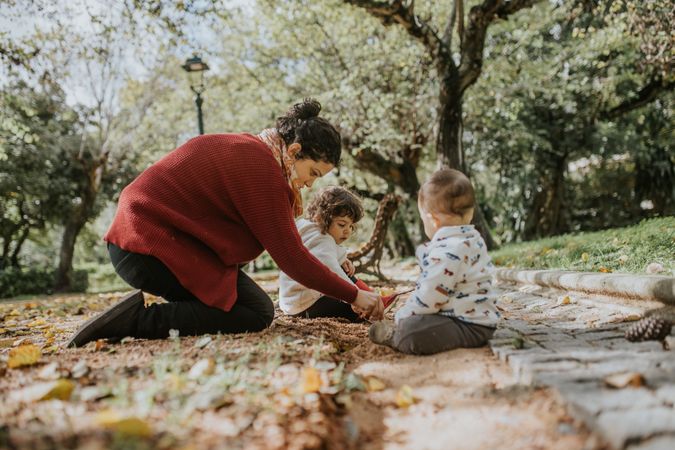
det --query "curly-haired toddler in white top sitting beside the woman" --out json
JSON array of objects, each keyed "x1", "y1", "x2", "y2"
[{"x1": 279, "y1": 186, "x2": 370, "y2": 322}]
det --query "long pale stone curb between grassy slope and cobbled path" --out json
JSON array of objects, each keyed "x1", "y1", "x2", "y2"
[{"x1": 496, "y1": 269, "x2": 675, "y2": 305}]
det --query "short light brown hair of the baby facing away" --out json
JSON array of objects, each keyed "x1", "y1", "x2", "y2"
[{"x1": 418, "y1": 169, "x2": 475, "y2": 216}]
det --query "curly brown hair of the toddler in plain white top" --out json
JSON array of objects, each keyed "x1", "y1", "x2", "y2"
[{"x1": 307, "y1": 186, "x2": 363, "y2": 233}]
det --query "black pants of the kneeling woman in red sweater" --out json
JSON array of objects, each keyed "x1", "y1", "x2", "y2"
[{"x1": 108, "y1": 243, "x2": 274, "y2": 339}]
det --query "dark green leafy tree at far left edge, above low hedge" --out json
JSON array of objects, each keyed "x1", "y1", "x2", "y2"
[{"x1": 0, "y1": 82, "x2": 78, "y2": 268}]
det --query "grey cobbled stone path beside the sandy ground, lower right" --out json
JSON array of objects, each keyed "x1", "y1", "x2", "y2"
[{"x1": 490, "y1": 284, "x2": 675, "y2": 450}]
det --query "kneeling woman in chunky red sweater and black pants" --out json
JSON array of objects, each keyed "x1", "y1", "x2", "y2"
[{"x1": 68, "y1": 99, "x2": 383, "y2": 346}]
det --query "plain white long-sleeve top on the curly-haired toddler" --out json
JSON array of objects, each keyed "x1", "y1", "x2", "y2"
[{"x1": 279, "y1": 219, "x2": 352, "y2": 314}]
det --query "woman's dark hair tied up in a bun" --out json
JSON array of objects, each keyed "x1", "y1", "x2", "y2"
[{"x1": 276, "y1": 98, "x2": 342, "y2": 167}]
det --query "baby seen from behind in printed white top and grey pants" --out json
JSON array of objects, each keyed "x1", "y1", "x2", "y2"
[{"x1": 369, "y1": 169, "x2": 499, "y2": 354}]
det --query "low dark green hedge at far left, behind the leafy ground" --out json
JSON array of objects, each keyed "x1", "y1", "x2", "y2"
[{"x1": 0, "y1": 267, "x2": 89, "y2": 298}]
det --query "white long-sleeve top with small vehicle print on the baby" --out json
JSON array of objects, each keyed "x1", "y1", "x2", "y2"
[{"x1": 395, "y1": 225, "x2": 500, "y2": 327}]
